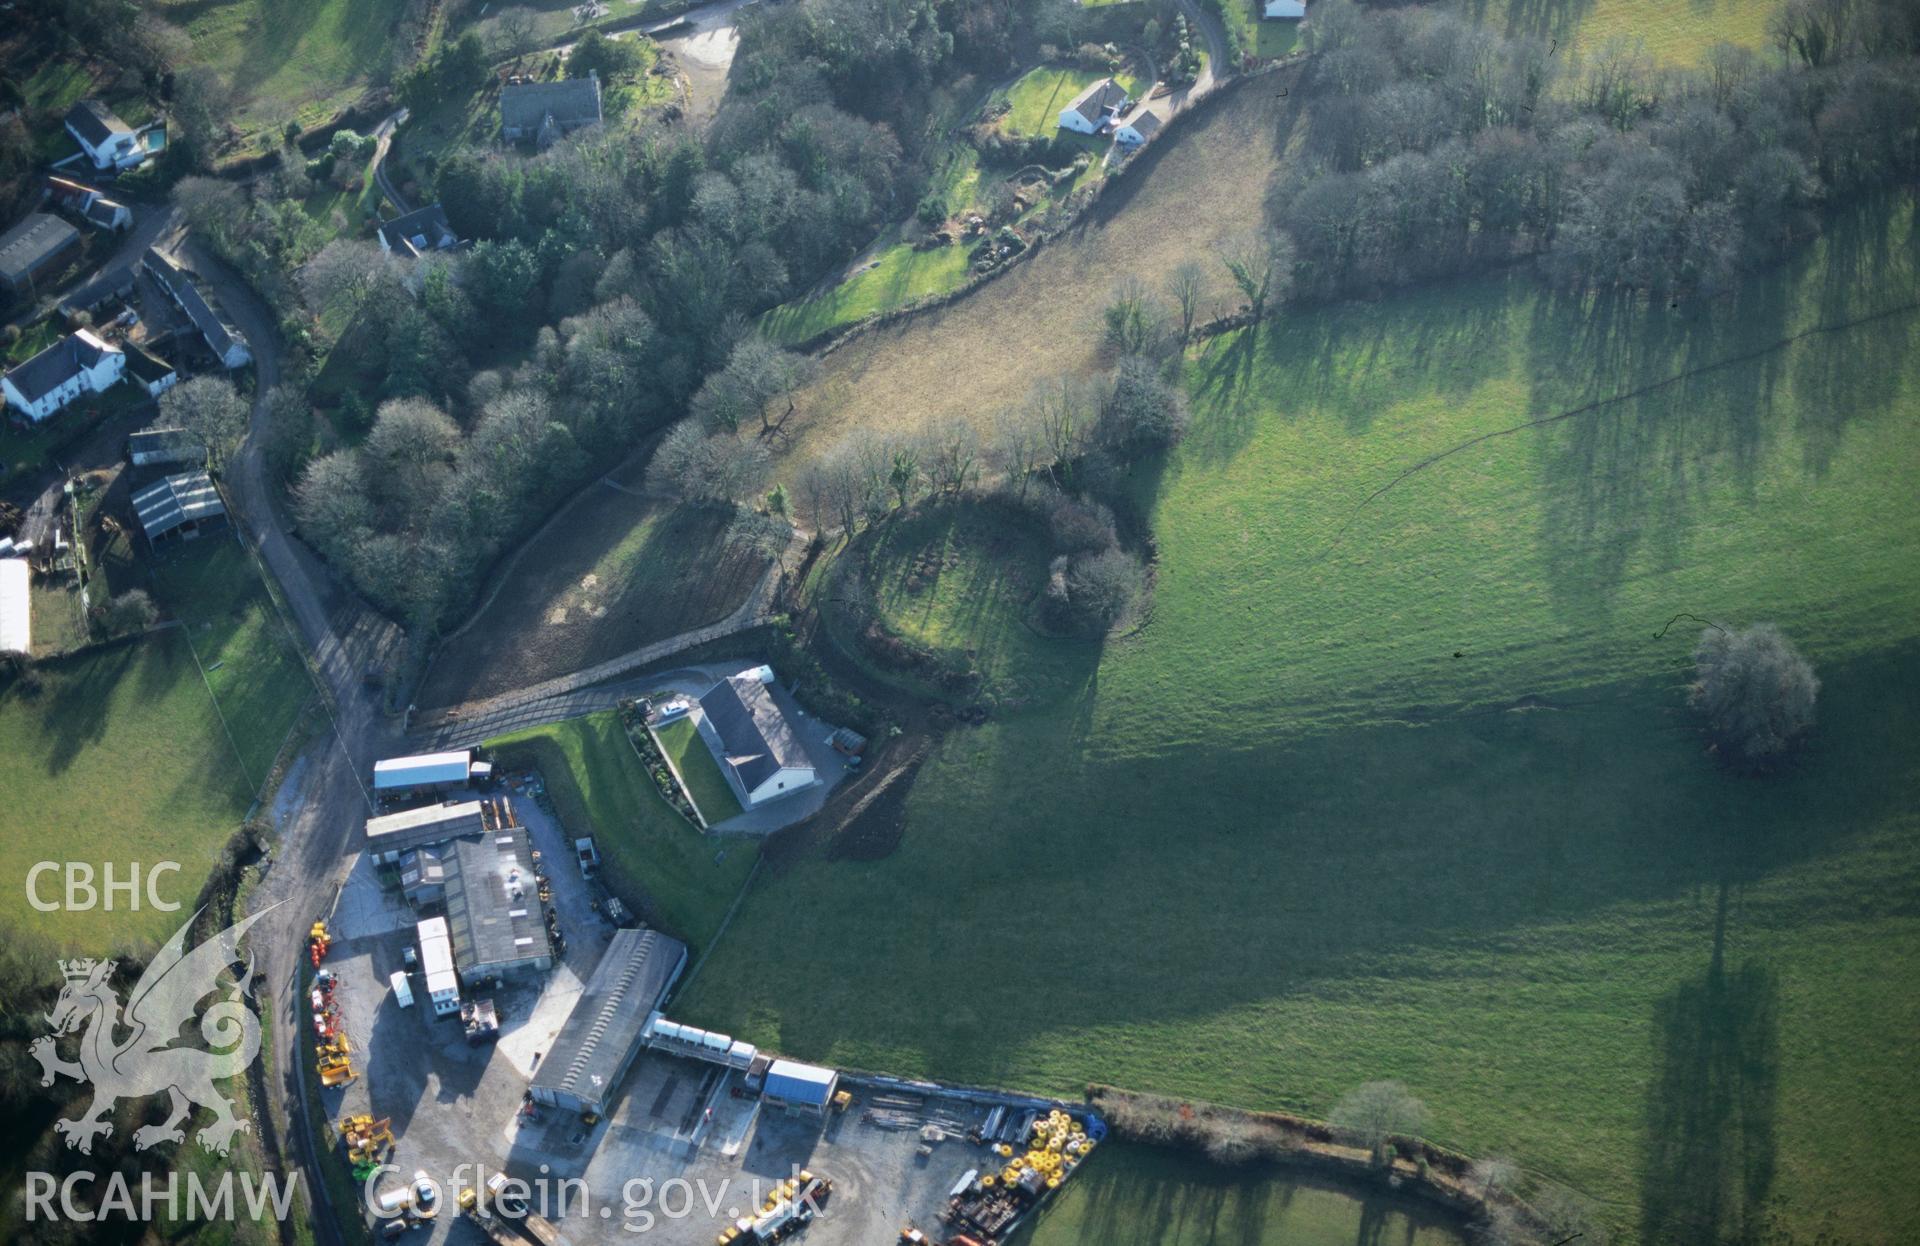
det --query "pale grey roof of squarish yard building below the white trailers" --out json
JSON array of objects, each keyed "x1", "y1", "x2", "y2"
[{"x1": 442, "y1": 826, "x2": 553, "y2": 977}]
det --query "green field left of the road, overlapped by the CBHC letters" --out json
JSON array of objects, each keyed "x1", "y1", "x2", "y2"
[{"x1": 0, "y1": 536, "x2": 311, "y2": 954}]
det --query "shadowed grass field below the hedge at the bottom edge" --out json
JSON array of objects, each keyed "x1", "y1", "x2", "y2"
[{"x1": 1021, "y1": 1144, "x2": 1465, "y2": 1246}]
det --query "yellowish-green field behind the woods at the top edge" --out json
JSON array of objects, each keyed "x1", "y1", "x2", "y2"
[{"x1": 1455, "y1": 0, "x2": 1780, "y2": 65}]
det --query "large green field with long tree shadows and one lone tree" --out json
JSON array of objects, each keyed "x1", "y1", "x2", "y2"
[{"x1": 682, "y1": 202, "x2": 1920, "y2": 1242}]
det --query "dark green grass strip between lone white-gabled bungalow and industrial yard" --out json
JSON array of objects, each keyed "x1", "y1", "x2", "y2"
[{"x1": 488, "y1": 710, "x2": 758, "y2": 950}]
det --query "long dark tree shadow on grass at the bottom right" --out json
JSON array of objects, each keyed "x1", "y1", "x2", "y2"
[{"x1": 1640, "y1": 883, "x2": 1780, "y2": 1246}]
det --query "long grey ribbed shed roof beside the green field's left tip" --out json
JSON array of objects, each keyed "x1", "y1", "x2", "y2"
[{"x1": 534, "y1": 929, "x2": 687, "y2": 1110}]
